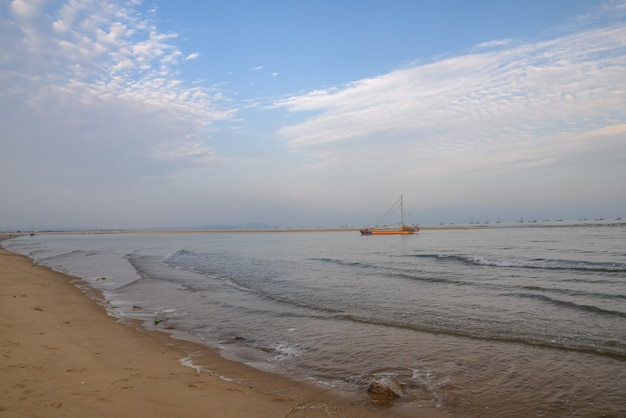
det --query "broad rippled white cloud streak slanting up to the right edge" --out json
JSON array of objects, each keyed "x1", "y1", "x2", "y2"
[{"x1": 276, "y1": 25, "x2": 626, "y2": 176}]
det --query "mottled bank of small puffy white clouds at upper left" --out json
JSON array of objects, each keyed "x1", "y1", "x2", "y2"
[{"x1": 0, "y1": 0, "x2": 234, "y2": 177}]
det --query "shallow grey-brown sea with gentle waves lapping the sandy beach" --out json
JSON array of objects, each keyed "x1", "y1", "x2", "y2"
[{"x1": 2, "y1": 221, "x2": 626, "y2": 417}]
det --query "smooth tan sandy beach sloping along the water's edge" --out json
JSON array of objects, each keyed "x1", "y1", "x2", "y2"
[{"x1": 0, "y1": 237, "x2": 449, "y2": 418}]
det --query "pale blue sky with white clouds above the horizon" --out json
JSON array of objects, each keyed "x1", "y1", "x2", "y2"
[{"x1": 0, "y1": 0, "x2": 626, "y2": 228}]
